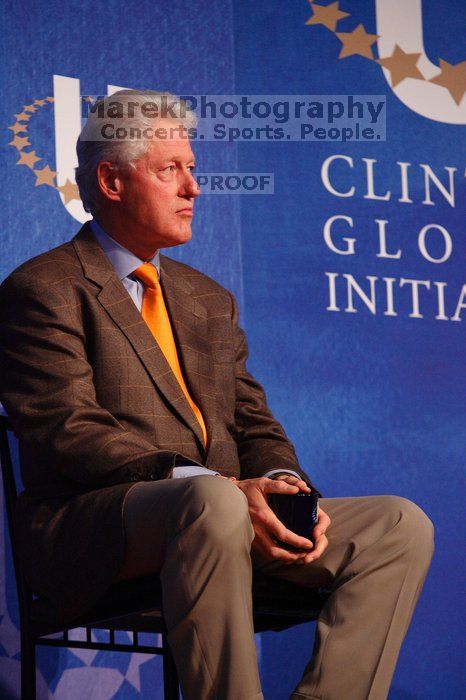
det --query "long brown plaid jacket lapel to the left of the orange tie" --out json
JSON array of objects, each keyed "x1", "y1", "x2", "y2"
[{"x1": 73, "y1": 225, "x2": 208, "y2": 454}]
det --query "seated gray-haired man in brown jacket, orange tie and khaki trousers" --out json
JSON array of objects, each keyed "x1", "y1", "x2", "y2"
[{"x1": 0, "y1": 91, "x2": 433, "y2": 700}]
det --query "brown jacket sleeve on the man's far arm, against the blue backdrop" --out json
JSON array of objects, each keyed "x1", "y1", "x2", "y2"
[{"x1": 231, "y1": 296, "x2": 321, "y2": 495}]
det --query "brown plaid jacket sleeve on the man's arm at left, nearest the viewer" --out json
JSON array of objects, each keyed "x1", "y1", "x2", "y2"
[{"x1": 0, "y1": 273, "x2": 200, "y2": 488}]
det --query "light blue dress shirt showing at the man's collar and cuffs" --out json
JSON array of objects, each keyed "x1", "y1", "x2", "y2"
[{"x1": 90, "y1": 219, "x2": 301, "y2": 479}]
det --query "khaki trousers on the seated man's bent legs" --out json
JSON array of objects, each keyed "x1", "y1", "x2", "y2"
[{"x1": 119, "y1": 476, "x2": 433, "y2": 700}]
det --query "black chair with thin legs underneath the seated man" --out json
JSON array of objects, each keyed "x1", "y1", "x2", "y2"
[{"x1": 0, "y1": 416, "x2": 329, "y2": 700}]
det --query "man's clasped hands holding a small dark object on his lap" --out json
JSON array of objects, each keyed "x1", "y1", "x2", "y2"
[{"x1": 236, "y1": 475, "x2": 317, "y2": 564}]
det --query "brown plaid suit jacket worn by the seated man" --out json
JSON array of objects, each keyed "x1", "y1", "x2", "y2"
[{"x1": 0, "y1": 225, "x2": 316, "y2": 617}]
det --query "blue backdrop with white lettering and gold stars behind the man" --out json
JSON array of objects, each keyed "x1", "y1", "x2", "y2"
[{"x1": 0, "y1": 0, "x2": 465, "y2": 700}]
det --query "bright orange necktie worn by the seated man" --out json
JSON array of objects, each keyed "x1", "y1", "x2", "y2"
[{"x1": 133, "y1": 263, "x2": 207, "y2": 445}]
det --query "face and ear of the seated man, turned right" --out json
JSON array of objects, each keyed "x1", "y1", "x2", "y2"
[{"x1": 114, "y1": 119, "x2": 199, "y2": 259}]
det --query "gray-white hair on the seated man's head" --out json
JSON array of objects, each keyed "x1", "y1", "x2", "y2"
[{"x1": 76, "y1": 90, "x2": 197, "y2": 215}]
